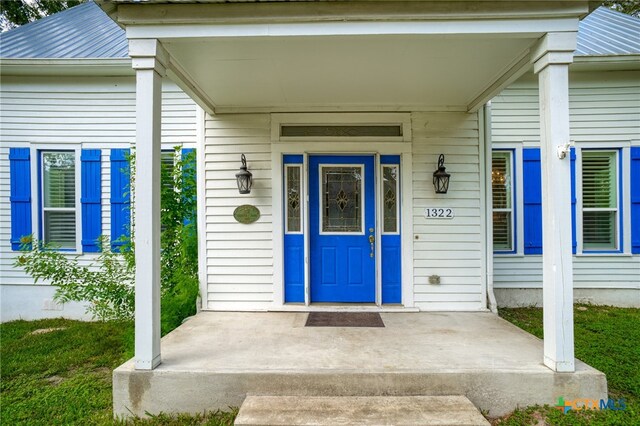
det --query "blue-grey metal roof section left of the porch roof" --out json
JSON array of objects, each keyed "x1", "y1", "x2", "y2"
[{"x1": 0, "y1": 2, "x2": 129, "y2": 59}]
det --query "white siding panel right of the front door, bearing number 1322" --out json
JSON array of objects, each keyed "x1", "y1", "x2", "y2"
[{"x1": 411, "y1": 112, "x2": 485, "y2": 311}]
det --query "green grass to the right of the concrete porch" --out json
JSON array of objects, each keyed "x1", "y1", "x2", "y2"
[{"x1": 492, "y1": 305, "x2": 640, "y2": 426}]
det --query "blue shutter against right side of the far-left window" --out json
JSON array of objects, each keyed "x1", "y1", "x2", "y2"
[{"x1": 80, "y1": 149, "x2": 102, "y2": 253}]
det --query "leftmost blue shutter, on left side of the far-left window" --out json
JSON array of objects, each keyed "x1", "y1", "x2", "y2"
[{"x1": 9, "y1": 148, "x2": 32, "y2": 250}]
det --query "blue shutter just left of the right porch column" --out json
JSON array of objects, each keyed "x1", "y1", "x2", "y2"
[{"x1": 522, "y1": 148, "x2": 542, "y2": 254}]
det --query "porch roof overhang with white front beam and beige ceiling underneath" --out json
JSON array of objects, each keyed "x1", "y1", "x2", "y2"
[{"x1": 106, "y1": 0, "x2": 589, "y2": 113}]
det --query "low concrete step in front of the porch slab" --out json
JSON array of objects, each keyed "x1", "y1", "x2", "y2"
[{"x1": 235, "y1": 395, "x2": 489, "y2": 426}]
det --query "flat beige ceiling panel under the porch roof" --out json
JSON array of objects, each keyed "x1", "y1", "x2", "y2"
[{"x1": 161, "y1": 34, "x2": 541, "y2": 112}]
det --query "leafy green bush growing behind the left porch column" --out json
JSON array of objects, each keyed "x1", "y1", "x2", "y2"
[{"x1": 15, "y1": 147, "x2": 198, "y2": 334}]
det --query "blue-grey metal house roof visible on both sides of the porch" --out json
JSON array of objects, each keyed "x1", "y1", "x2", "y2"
[{"x1": 0, "y1": 2, "x2": 640, "y2": 59}]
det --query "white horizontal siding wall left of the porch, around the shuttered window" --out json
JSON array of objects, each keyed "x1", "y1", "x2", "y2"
[{"x1": 0, "y1": 76, "x2": 196, "y2": 322}]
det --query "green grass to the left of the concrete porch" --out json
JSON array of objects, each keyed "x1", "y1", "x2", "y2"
[{"x1": 0, "y1": 319, "x2": 237, "y2": 425}]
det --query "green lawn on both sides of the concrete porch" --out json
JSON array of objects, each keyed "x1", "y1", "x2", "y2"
[{"x1": 0, "y1": 306, "x2": 640, "y2": 426}]
